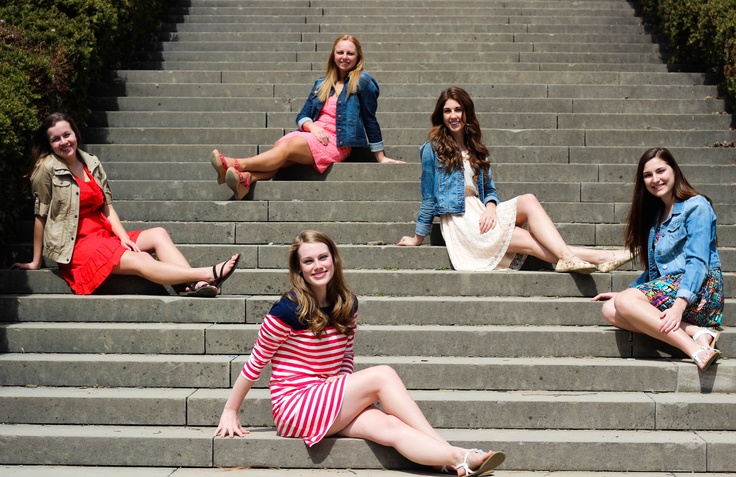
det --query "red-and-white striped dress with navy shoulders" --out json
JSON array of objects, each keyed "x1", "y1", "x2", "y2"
[{"x1": 241, "y1": 297, "x2": 357, "y2": 447}]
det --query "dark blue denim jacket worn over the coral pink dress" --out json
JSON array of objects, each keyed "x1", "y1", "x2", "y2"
[{"x1": 296, "y1": 72, "x2": 383, "y2": 152}]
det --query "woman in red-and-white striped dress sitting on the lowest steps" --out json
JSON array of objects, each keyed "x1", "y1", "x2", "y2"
[{"x1": 215, "y1": 230, "x2": 505, "y2": 477}]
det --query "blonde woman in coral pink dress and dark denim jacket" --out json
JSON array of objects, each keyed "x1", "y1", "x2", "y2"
[{"x1": 210, "y1": 35, "x2": 401, "y2": 200}]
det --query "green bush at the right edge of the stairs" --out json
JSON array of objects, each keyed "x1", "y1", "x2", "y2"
[{"x1": 642, "y1": 0, "x2": 736, "y2": 99}]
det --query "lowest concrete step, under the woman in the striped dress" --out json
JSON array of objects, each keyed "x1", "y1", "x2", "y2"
[{"x1": 0, "y1": 425, "x2": 734, "y2": 472}]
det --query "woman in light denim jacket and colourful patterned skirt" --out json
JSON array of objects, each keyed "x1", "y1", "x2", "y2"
[{"x1": 593, "y1": 148, "x2": 723, "y2": 371}]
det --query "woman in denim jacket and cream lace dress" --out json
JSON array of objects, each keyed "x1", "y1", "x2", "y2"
[{"x1": 398, "y1": 87, "x2": 630, "y2": 273}]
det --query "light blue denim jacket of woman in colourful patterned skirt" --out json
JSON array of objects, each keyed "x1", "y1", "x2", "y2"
[{"x1": 631, "y1": 195, "x2": 721, "y2": 303}]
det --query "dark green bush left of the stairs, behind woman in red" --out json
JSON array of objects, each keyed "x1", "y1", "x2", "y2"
[{"x1": 0, "y1": 0, "x2": 166, "y2": 243}]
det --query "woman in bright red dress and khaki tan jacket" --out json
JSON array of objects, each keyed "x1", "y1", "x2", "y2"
[{"x1": 11, "y1": 113, "x2": 240, "y2": 297}]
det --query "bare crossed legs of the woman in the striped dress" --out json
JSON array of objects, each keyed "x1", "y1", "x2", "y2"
[{"x1": 328, "y1": 366, "x2": 500, "y2": 475}]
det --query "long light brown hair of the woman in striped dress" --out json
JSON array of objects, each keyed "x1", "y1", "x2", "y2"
[{"x1": 285, "y1": 230, "x2": 357, "y2": 338}]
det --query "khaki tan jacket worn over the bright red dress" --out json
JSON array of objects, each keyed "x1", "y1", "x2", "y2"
[{"x1": 31, "y1": 150, "x2": 112, "y2": 263}]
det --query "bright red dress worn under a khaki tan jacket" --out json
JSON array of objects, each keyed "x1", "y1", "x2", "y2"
[{"x1": 59, "y1": 166, "x2": 141, "y2": 295}]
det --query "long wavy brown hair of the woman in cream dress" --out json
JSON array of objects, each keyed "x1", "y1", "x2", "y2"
[{"x1": 429, "y1": 86, "x2": 490, "y2": 178}]
